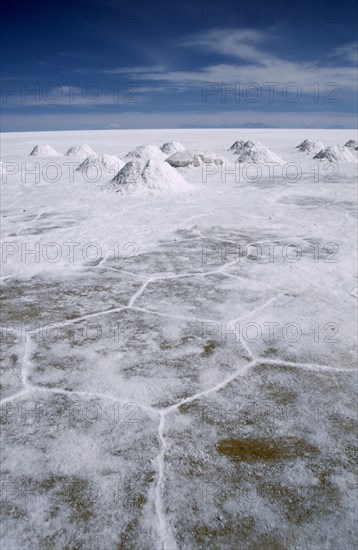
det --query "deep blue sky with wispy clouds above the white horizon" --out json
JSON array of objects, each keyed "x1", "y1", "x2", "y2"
[{"x1": 1, "y1": 0, "x2": 357, "y2": 131}]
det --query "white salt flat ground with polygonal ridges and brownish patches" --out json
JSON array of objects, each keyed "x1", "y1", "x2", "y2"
[{"x1": 1, "y1": 130, "x2": 356, "y2": 550}]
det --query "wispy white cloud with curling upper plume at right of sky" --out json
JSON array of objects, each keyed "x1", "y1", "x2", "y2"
[{"x1": 99, "y1": 29, "x2": 356, "y2": 92}]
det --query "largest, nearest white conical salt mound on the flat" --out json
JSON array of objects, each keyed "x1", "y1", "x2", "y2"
[{"x1": 110, "y1": 159, "x2": 192, "y2": 196}]
